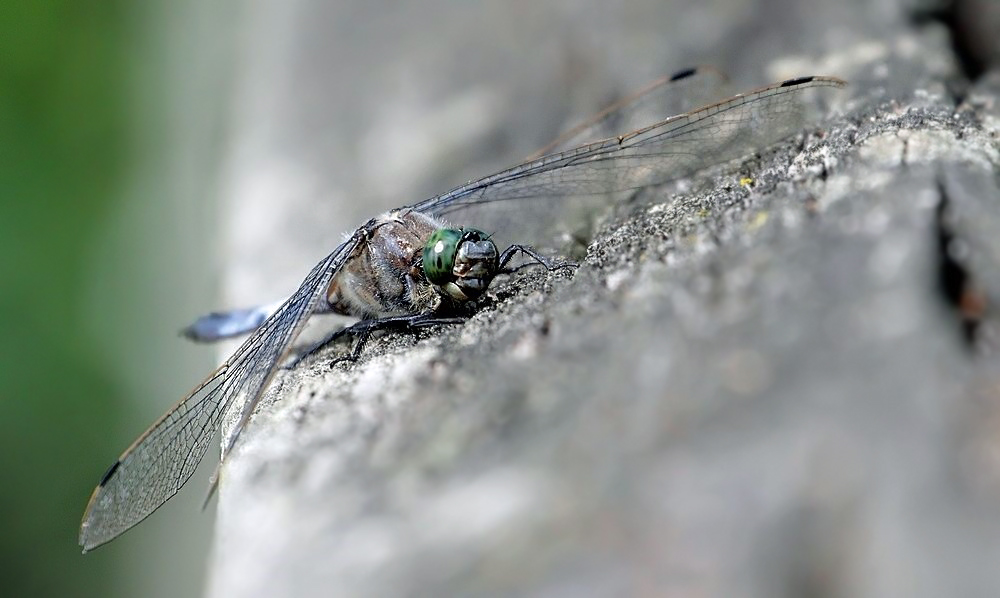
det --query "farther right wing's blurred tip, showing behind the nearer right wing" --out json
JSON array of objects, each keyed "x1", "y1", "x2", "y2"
[{"x1": 528, "y1": 66, "x2": 726, "y2": 160}]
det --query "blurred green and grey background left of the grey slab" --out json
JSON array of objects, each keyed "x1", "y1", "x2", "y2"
[{"x1": 0, "y1": 0, "x2": 233, "y2": 596}]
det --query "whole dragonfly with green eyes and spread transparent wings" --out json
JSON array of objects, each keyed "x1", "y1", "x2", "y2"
[{"x1": 79, "y1": 68, "x2": 846, "y2": 552}]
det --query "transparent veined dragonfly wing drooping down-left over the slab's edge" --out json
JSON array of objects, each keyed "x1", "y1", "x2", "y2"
[{"x1": 80, "y1": 235, "x2": 359, "y2": 551}]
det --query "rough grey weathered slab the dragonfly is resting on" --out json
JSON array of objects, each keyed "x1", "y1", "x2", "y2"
[{"x1": 199, "y1": 1, "x2": 1000, "y2": 598}]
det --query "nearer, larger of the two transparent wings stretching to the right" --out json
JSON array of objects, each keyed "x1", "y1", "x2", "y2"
[{"x1": 413, "y1": 76, "x2": 846, "y2": 251}]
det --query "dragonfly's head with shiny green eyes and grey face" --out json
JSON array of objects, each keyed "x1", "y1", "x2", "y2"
[{"x1": 423, "y1": 228, "x2": 500, "y2": 301}]
